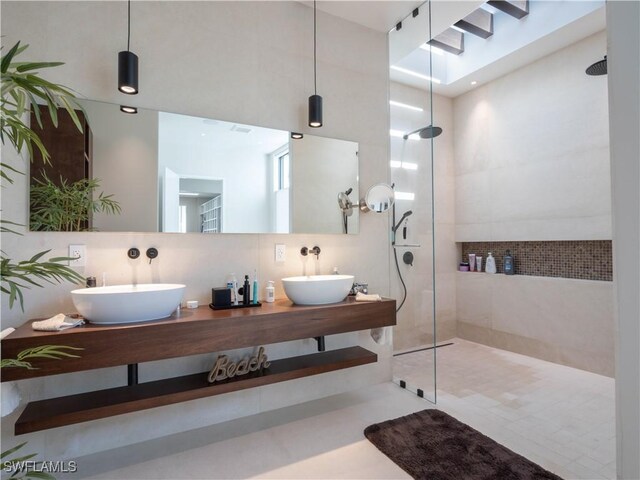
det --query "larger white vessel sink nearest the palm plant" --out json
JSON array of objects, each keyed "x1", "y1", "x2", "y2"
[{"x1": 71, "y1": 283, "x2": 186, "y2": 324}]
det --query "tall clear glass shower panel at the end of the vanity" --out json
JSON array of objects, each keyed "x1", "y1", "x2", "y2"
[{"x1": 389, "y1": 2, "x2": 442, "y2": 402}]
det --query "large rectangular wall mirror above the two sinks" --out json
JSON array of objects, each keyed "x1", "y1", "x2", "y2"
[{"x1": 30, "y1": 100, "x2": 359, "y2": 234}]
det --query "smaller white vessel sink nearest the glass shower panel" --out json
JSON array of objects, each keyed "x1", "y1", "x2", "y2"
[{"x1": 282, "y1": 275, "x2": 354, "y2": 305}]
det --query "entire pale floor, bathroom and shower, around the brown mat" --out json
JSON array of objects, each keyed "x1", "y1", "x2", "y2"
[{"x1": 73, "y1": 339, "x2": 615, "y2": 479}]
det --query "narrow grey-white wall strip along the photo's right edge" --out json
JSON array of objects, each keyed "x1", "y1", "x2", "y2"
[{"x1": 607, "y1": 1, "x2": 640, "y2": 479}]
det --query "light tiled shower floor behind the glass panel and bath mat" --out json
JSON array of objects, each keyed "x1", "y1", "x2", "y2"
[{"x1": 394, "y1": 339, "x2": 616, "y2": 479}]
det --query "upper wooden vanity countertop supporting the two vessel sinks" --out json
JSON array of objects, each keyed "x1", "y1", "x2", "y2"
[{"x1": 2, "y1": 297, "x2": 396, "y2": 382}]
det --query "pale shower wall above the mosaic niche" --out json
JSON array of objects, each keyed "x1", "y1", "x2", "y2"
[{"x1": 453, "y1": 32, "x2": 611, "y2": 242}]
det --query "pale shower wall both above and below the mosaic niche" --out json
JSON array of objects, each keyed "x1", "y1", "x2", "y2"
[{"x1": 453, "y1": 32, "x2": 614, "y2": 376}]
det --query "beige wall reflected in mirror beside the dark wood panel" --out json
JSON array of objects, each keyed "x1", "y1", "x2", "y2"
[{"x1": 82, "y1": 102, "x2": 158, "y2": 232}]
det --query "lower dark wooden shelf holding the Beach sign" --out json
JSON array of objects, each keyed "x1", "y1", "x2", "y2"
[{"x1": 15, "y1": 347, "x2": 378, "y2": 435}]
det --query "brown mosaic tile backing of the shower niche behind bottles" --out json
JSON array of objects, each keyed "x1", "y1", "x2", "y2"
[{"x1": 462, "y1": 240, "x2": 613, "y2": 282}]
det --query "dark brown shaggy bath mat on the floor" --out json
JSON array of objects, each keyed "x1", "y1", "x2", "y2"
[{"x1": 364, "y1": 409, "x2": 561, "y2": 480}]
